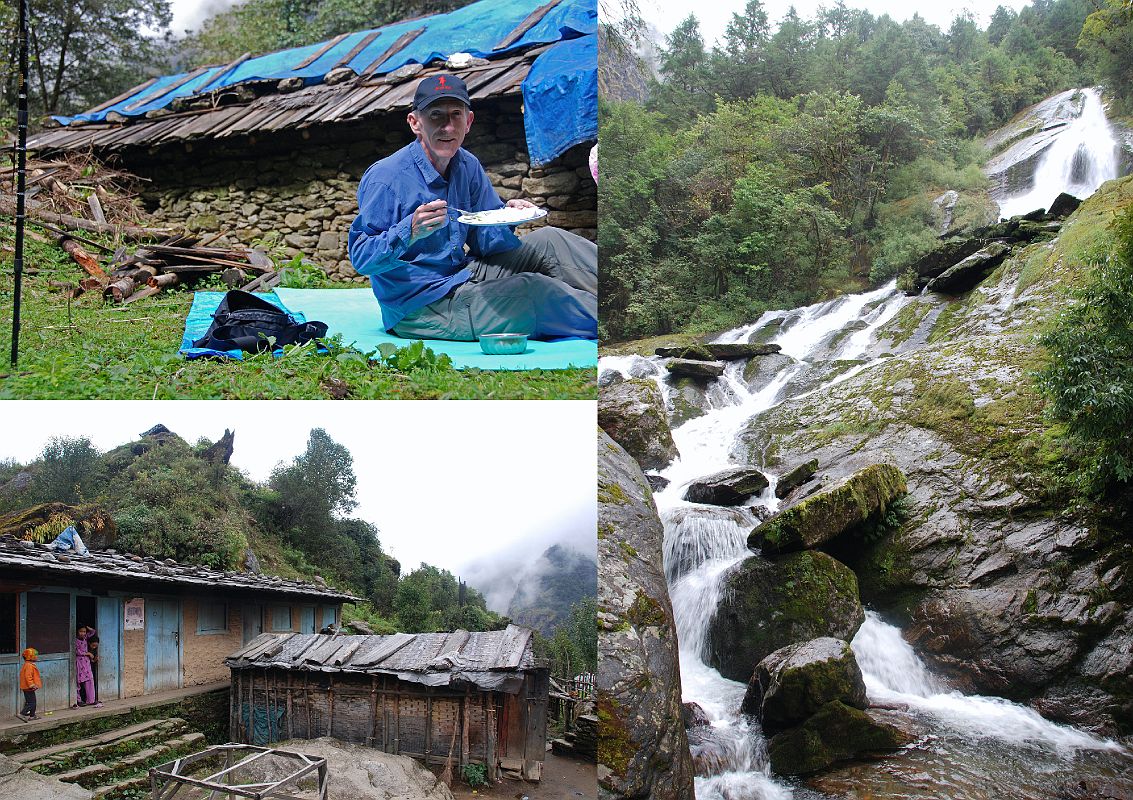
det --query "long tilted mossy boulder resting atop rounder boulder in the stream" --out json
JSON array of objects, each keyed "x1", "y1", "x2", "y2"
[{"x1": 748, "y1": 463, "x2": 908, "y2": 553}]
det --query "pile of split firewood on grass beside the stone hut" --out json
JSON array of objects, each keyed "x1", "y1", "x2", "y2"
[{"x1": 58, "y1": 231, "x2": 280, "y2": 303}]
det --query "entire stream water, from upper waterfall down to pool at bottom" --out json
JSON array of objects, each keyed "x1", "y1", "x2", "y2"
[{"x1": 599, "y1": 90, "x2": 1133, "y2": 784}]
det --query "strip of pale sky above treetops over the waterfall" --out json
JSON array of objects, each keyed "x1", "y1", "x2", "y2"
[{"x1": 639, "y1": 0, "x2": 1031, "y2": 45}]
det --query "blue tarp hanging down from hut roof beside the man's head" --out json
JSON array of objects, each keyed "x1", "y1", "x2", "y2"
[{"x1": 523, "y1": 36, "x2": 598, "y2": 164}]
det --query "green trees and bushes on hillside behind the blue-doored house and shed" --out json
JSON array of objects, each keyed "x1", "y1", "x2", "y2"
[{"x1": 0, "y1": 428, "x2": 596, "y2": 675}]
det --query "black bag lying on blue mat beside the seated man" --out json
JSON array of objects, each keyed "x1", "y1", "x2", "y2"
[{"x1": 193, "y1": 289, "x2": 326, "y2": 352}]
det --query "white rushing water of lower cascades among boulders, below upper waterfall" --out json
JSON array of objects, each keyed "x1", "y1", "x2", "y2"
[{"x1": 600, "y1": 273, "x2": 1116, "y2": 800}]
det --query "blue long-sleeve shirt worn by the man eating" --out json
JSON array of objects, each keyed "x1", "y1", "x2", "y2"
[{"x1": 348, "y1": 142, "x2": 519, "y2": 330}]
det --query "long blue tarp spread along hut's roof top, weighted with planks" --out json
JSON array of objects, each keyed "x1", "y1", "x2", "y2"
[{"x1": 54, "y1": 0, "x2": 598, "y2": 125}]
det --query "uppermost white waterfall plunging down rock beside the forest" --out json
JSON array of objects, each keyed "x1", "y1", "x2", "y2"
[{"x1": 999, "y1": 88, "x2": 1118, "y2": 218}]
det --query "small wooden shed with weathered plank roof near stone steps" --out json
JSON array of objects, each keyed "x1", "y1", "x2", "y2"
[{"x1": 224, "y1": 625, "x2": 550, "y2": 780}]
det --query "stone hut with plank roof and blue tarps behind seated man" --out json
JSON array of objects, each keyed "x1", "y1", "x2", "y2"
[{"x1": 28, "y1": 0, "x2": 597, "y2": 282}]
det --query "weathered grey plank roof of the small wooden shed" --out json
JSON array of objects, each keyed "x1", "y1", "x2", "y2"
[{"x1": 224, "y1": 625, "x2": 535, "y2": 689}]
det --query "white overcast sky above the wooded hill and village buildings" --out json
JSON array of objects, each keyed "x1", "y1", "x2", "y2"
[{"x1": 0, "y1": 400, "x2": 597, "y2": 608}]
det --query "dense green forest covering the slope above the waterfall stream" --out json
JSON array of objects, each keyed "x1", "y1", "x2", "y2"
[{"x1": 598, "y1": 0, "x2": 1133, "y2": 341}]
